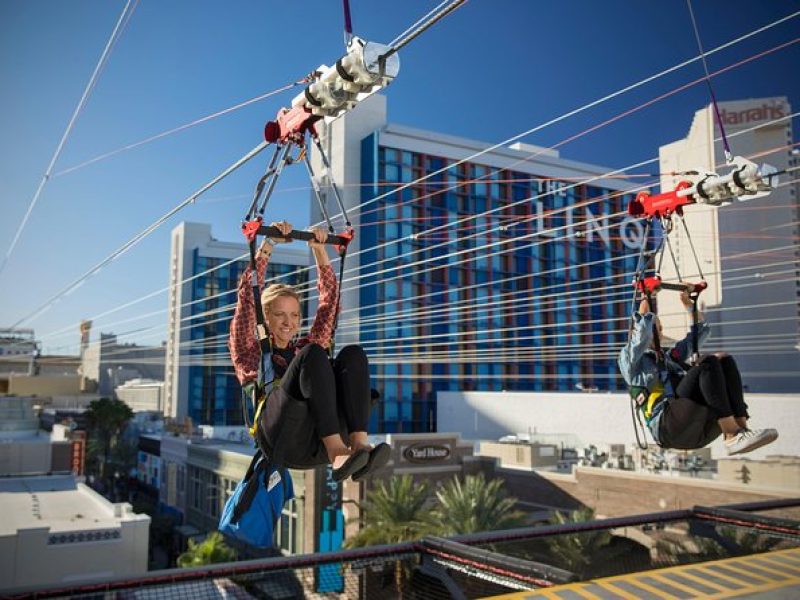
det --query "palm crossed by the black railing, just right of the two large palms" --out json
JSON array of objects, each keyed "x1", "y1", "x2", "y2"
[{"x1": 547, "y1": 508, "x2": 612, "y2": 578}]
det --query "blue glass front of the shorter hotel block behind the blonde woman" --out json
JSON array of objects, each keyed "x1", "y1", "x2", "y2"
[{"x1": 188, "y1": 250, "x2": 308, "y2": 425}]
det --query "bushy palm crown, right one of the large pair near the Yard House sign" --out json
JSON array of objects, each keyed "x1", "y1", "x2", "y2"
[{"x1": 434, "y1": 473, "x2": 526, "y2": 535}]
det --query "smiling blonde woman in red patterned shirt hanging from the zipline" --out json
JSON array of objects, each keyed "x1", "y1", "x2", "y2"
[{"x1": 228, "y1": 221, "x2": 390, "y2": 481}]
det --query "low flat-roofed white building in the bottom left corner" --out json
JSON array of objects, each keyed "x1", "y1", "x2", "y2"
[{"x1": 0, "y1": 475, "x2": 150, "y2": 591}]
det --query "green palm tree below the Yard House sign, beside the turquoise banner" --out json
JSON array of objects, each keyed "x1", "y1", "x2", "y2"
[{"x1": 344, "y1": 475, "x2": 438, "y2": 598}]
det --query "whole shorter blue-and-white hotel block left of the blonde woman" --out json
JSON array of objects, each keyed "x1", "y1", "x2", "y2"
[{"x1": 163, "y1": 222, "x2": 309, "y2": 425}]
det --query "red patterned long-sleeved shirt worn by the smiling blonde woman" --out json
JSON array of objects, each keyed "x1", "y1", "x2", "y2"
[{"x1": 228, "y1": 257, "x2": 338, "y2": 385}]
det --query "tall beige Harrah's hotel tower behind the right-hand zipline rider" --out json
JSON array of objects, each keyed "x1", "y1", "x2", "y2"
[{"x1": 659, "y1": 97, "x2": 800, "y2": 393}]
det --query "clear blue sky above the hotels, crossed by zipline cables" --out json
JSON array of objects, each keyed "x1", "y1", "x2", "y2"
[{"x1": 0, "y1": 0, "x2": 800, "y2": 353}]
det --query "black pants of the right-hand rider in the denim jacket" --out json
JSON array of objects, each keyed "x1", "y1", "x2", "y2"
[{"x1": 659, "y1": 355, "x2": 748, "y2": 450}]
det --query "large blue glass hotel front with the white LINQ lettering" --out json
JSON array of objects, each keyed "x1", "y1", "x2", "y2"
[{"x1": 359, "y1": 134, "x2": 638, "y2": 433}]
